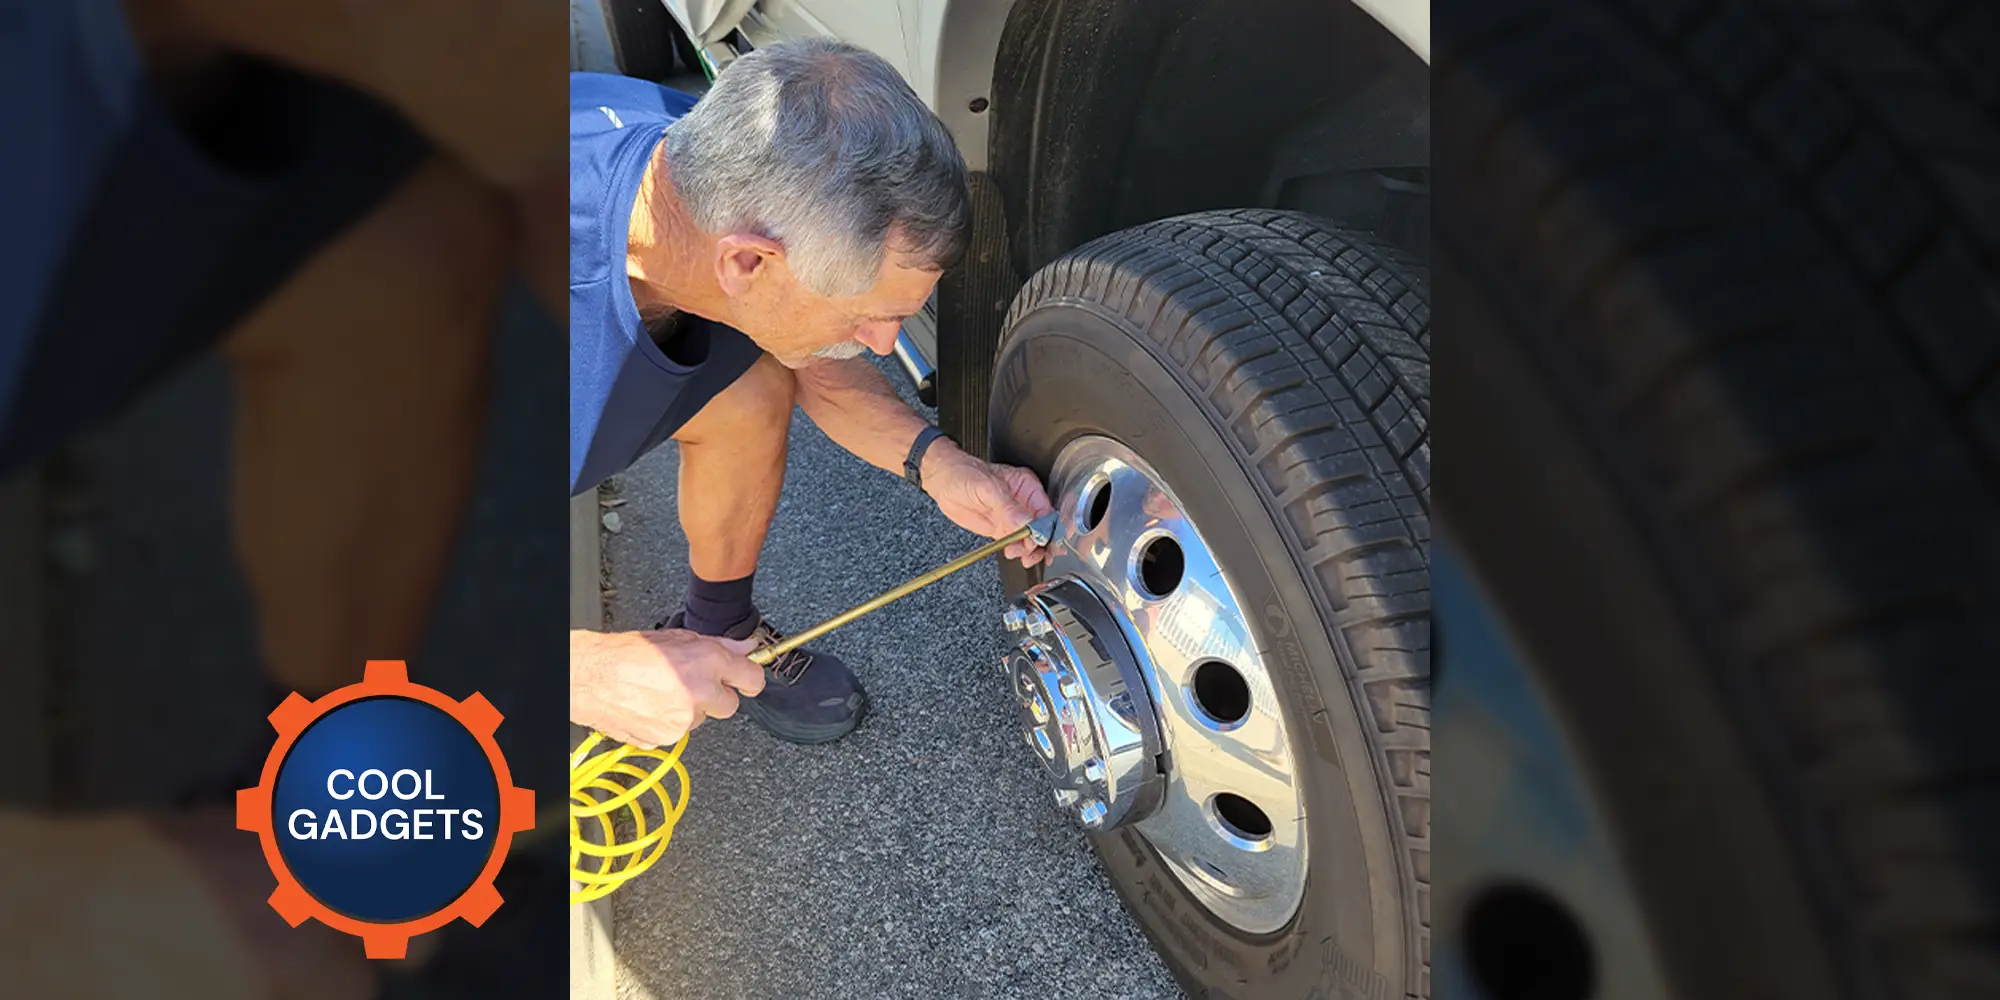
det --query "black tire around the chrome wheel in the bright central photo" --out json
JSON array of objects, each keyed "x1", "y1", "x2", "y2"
[{"x1": 990, "y1": 210, "x2": 1430, "y2": 998}]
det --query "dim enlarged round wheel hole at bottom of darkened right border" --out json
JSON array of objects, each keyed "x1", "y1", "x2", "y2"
[{"x1": 1464, "y1": 884, "x2": 1596, "y2": 1000}]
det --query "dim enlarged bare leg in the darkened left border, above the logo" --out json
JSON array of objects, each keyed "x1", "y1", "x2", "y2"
[{"x1": 213, "y1": 160, "x2": 508, "y2": 692}]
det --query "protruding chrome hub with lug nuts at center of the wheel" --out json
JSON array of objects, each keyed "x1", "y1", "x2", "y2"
[{"x1": 1002, "y1": 580, "x2": 1164, "y2": 830}]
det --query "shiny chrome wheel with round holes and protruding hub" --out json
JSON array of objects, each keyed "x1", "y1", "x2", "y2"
[{"x1": 1002, "y1": 436, "x2": 1306, "y2": 934}]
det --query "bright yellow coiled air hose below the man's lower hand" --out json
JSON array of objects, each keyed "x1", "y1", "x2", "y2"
[{"x1": 570, "y1": 732, "x2": 688, "y2": 904}]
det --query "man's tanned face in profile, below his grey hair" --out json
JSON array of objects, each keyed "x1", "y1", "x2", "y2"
[{"x1": 720, "y1": 240, "x2": 940, "y2": 368}]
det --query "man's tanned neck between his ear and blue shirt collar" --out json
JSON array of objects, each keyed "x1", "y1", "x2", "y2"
[{"x1": 626, "y1": 142, "x2": 728, "y2": 322}]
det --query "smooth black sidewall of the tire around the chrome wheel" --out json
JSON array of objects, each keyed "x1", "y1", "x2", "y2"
[{"x1": 988, "y1": 300, "x2": 1412, "y2": 996}]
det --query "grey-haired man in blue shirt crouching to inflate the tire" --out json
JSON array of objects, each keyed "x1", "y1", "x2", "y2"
[{"x1": 570, "y1": 40, "x2": 1050, "y2": 746}]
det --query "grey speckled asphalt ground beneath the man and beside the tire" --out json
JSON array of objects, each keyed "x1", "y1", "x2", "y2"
[{"x1": 604, "y1": 354, "x2": 1182, "y2": 1000}]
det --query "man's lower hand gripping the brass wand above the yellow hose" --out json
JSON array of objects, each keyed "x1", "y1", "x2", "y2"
[{"x1": 570, "y1": 628, "x2": 764, "y2": 748}]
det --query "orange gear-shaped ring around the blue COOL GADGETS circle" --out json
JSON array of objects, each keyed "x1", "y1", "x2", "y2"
[{"x1": 236, "y1": 660, "x2": 534, "y2": 958}]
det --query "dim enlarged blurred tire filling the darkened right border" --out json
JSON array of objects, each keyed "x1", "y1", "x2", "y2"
[{"x1": 1434, "y1": 0, "x2": 2000, "y2": 1000}]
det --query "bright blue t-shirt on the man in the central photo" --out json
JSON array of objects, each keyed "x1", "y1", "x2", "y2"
[{"x1": 570, "y1": 72, "x2": 760, "y2": 496}]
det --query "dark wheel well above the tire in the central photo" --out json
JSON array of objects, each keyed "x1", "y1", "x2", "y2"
[{"x1": 988, "y1": 0, "x2": 1430, "y2": 276}]
